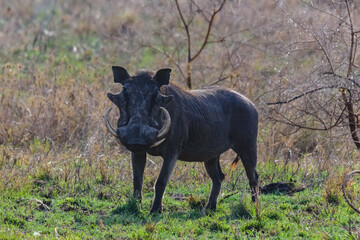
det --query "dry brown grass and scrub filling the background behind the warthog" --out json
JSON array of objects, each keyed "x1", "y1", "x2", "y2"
[{"x1": 0, "y1": 0, "x2": 360, "y2": 238}]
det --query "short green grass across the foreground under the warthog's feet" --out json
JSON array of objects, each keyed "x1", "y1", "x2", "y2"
[{"x1": 0, "y1": 159, "x2": 360, "y2": 239}]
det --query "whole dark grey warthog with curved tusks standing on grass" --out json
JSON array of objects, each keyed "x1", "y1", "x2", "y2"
[{"x1": 105, "y1": 66, "x2": 258, "y2": 212}]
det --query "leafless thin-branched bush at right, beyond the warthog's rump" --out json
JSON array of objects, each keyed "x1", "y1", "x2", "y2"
[{"x1": 266, "y1": 1, "x2": 360, "y2": 154}]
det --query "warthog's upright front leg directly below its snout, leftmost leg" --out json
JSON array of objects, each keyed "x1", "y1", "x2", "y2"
[{"x1": 131, "y1": 153, "x2": 146, "y2": 202}]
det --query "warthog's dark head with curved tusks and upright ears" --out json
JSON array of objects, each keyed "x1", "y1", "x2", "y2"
[{"x1": 105, "y1": 66, "x2": 172, "y2": 152}]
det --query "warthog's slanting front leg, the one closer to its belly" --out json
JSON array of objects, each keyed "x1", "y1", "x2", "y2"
[{"x1": 150, "y1": 156, "x2": 177, "y2": 213}]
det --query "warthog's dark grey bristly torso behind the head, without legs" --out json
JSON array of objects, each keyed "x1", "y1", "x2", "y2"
[{"x1": 162, "y1": 85, "x2": 257, "y2": 161}]
